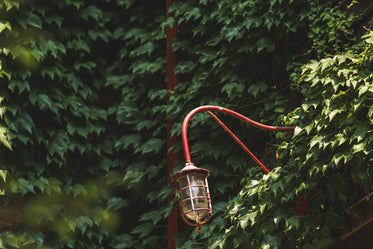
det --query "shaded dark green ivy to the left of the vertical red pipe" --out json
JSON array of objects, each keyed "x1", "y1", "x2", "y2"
[{"x1": 0, "y1": 0, "x2": 169, "y2": 248}]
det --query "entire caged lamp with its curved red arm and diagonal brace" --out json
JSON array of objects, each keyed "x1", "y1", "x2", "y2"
[{"x1": 172, "y1": 105, "x2": 294, "y2": 232}]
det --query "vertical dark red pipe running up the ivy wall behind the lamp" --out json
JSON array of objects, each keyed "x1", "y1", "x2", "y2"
[{"x1": 166, "y1": 0, "x2": 179, "y2": 249}]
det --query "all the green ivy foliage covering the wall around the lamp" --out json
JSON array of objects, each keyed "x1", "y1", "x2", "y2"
[{"x1": 0, "y1": 0, "x2": 373, "y2": 249}]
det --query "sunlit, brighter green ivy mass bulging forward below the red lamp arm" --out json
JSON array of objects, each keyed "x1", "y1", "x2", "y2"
[{"x1": 185, "y1": 33, "x2": 373, "y2": 248}]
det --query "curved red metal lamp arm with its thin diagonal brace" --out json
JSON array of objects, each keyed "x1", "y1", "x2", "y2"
[{"x1": 181, "y1": 105, "x2": 295, "y2": 169}]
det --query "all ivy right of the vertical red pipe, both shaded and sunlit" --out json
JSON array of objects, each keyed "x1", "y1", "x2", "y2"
[{"x1": 166, "y1": 1, "x2": 371, "y2": 248}]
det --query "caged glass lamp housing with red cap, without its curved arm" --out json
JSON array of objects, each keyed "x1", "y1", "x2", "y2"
[{"x1": 172, "y1": 162, "x2": 212, "y2": 226}]
